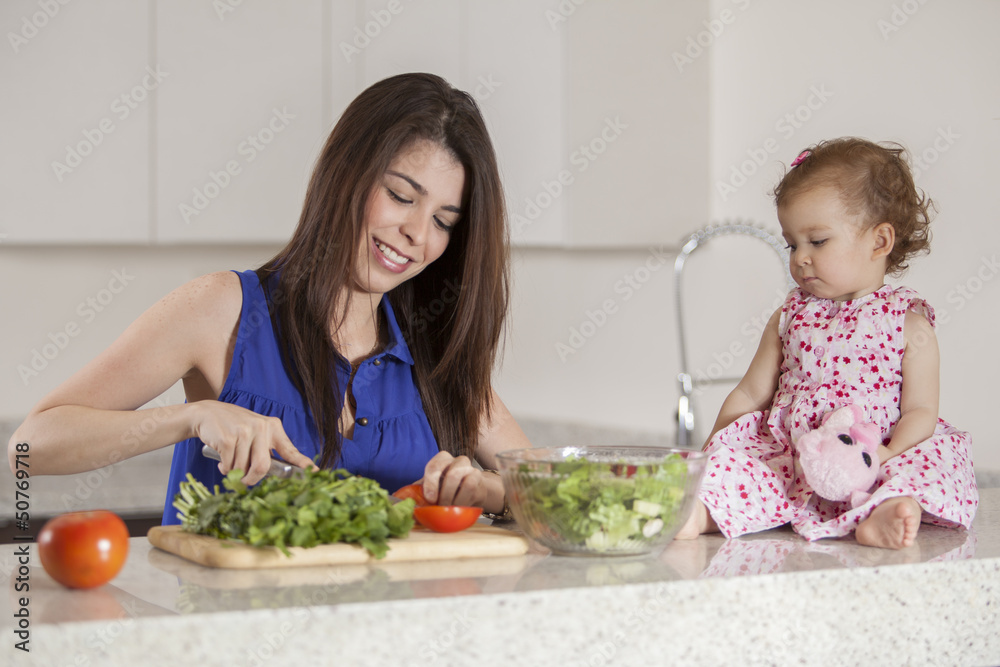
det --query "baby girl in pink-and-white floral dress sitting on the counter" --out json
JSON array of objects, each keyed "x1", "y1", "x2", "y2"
[{"x1": 678, "y1": 138, "x2": 978, "y2": 549}]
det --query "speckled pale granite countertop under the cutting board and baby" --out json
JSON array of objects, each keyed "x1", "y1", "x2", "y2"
[{"x1": 0, "y1": 489, "x2": 1000, "y2": 667}]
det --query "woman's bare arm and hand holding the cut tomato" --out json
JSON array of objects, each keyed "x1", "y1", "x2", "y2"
[{"x1": 423, "y1": 392, "x2": 531, "y2": 514}]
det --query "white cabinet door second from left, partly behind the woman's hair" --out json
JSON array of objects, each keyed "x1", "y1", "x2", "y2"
[{"x1": 156, "y1": 0, "x2": 329, "y2": 243}]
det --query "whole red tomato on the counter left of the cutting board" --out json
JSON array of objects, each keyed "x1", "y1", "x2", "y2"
[{"x1": 38, "y1": 510, "x2": 128, "y2": 588}]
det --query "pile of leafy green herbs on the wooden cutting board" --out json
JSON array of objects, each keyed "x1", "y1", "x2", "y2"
[{"x1": 173, "y1": 470, "x2": 414, "y2": 558}]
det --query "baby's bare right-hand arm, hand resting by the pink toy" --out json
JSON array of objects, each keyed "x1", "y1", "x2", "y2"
[{"x1": 879, "y1": 310, "x2": 940, "y2": 463}]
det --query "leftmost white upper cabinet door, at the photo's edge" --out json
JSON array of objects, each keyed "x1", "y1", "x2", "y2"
[{"x1": 0, "y1": 0, "x2": 150, "y2": 243}]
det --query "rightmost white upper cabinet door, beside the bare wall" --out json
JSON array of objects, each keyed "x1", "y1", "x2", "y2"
[{"x1": 561, "y1": 0, "x2": 712, "y2": 247}]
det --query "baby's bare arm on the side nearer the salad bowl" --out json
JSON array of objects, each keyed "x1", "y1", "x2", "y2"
[{"x1": 705, "y1": 308, "x2": 782, "y2": 447}]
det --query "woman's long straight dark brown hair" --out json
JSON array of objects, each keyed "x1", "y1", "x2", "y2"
[{"x1": 257, "y1": 74, "x2": 510, "y2": 467}]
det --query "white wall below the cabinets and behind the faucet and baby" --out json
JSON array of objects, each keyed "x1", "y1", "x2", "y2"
[{"x1": 0, "y1": 0, "x2": 1000, "y2": 469}]
